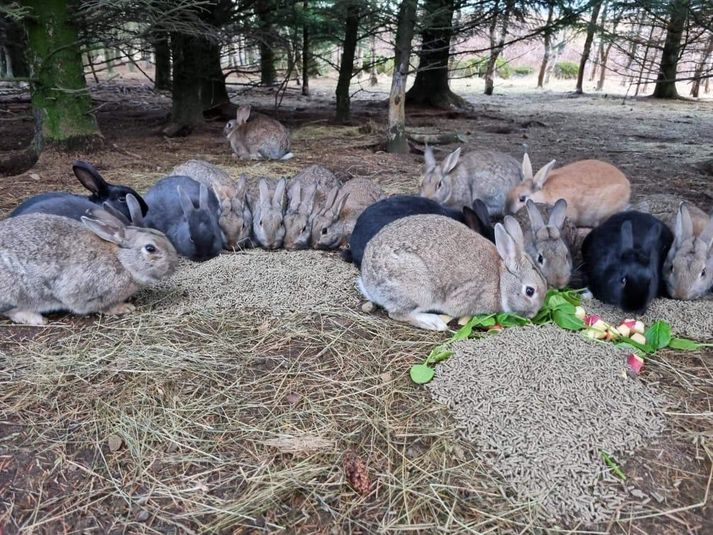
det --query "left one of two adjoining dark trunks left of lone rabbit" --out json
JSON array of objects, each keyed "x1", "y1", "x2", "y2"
[{"x1": 169, "y1": 33, "x2": 204, "y2": 135}]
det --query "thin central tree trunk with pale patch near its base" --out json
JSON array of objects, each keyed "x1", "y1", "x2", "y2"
[{"x1": 386, "y1": 0, "x2": 418, "y2": 154}]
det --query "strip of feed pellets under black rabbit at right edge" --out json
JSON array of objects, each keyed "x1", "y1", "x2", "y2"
[{"x1": 582, "y1": 296, "x2": 713, "y2": 341}]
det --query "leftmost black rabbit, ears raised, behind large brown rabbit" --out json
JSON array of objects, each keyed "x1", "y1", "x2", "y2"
[{"x1": 10, "y1": 160, "x2": 148, "y2": 221}]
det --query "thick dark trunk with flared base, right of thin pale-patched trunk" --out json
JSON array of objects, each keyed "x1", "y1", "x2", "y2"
[{"x1": 406, "y1": 0, "x2": 467, "y2": 109}]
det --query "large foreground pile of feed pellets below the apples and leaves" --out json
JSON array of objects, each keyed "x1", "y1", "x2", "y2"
[{"x1": 428, "y1": 325, "x2": 665, "y2": 524}]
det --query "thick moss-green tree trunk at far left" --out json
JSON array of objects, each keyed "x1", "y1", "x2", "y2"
[{"x1": 22, "y1": 0, "x2": 102, "y2": 153}]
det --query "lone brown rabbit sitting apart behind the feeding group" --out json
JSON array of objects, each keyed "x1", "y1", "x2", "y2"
[{"x1": 223, "y1": 106, "x2": 294, "y2": 160}]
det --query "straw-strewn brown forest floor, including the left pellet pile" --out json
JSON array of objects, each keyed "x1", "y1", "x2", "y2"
[{"x1": 0, "y1": 76, "x2": 713, "y2": 535}]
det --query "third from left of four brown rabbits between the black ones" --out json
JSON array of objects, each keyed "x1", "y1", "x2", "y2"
[{"x1": 284, "y1": 165, "x2": 339, "y2": 251}]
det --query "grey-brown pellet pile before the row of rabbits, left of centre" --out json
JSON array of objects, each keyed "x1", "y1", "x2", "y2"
[{"x1": 138, "y1": 250, "x2": 360, "y2": 314}]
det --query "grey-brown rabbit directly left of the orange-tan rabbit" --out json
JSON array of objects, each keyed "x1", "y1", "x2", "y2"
[{"x1": 420, "y1": 145, "x2": 522, "y2": 216}]
